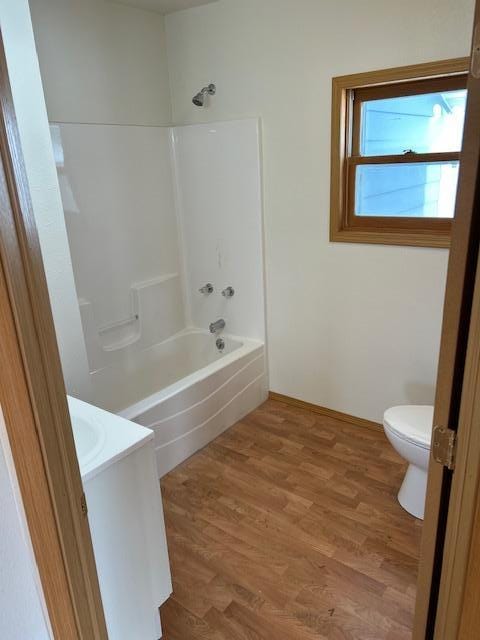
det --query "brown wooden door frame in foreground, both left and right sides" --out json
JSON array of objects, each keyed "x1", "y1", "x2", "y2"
[{"x1": 0, "y1": 0, "x2": 480, "y2": 640}]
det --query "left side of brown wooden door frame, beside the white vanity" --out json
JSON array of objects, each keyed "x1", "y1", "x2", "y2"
[{"x1": 0, "y1": 27, "x2": 108, "y2": 640}]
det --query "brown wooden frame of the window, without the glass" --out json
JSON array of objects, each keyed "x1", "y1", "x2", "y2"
[{"x1": 330, "y1": 58, "x2": 469, "y2": 248}]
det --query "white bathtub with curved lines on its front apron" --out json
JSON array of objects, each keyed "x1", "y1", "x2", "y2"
[{"x1": 91, "y1": 329, "x2": 268, "y2": 478}]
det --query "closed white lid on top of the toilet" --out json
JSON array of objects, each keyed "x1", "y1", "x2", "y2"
[{"x1": 383, "y1": 405, "x2": 433, "y2": 448}]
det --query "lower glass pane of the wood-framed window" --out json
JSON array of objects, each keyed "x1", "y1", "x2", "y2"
[{"x1": 355, "y1": 161, "x2": 459, "y2": 218}]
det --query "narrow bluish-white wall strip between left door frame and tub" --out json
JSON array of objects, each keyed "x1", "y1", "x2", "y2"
[{"x1": 0, "y1": 0, "x2": 90, "y2": 399}]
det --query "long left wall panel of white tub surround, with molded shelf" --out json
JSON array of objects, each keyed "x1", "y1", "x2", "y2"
[{"x1": 50, "y1": 123, "x2": 185, "y2": 364}]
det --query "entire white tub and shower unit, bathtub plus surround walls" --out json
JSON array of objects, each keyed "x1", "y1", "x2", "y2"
[{"x1": 51, "y1": 118, "x2": 268, "y2": 477}]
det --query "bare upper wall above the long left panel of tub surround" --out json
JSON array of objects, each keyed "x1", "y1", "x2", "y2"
[{"x1": 30, "y1": 0, "x2": 171, "y2": 125}]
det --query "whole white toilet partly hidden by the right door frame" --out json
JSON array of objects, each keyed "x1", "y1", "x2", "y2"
[{"x1": 383, "y1": 405, "x2": 433, "y2": 520}]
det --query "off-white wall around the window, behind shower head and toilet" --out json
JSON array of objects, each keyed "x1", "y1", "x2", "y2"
[{"x1": 166, "y1": 0, "x2": 473, "y2": 420}]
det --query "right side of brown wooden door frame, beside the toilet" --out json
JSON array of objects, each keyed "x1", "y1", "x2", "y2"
[{"x1": 413, "y1": 0, "x2": 480, "y2": 640}]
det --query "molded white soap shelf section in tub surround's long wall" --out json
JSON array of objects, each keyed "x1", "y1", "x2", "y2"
[{"x1": 78, "y1": 273, "x2": 185, "y2": 373}]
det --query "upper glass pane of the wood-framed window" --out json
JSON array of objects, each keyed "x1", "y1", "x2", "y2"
[{"x1": 360, "y1": 89, "x2": 467, "y2": 157}]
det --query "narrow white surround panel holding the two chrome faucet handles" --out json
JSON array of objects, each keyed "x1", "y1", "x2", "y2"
[{"x1": 173, "y1": 119, "x2": 265, "y2": 340}]
